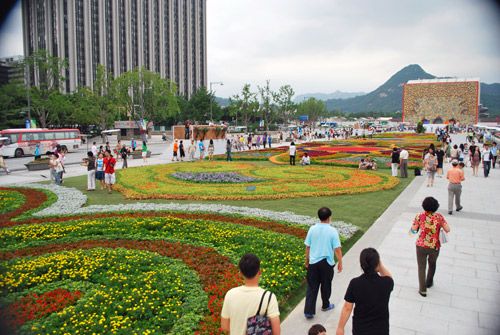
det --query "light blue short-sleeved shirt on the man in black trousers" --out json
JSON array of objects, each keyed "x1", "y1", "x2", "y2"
[{"x1": 304, "y1": 223, "x2": 340, "y2": 266}]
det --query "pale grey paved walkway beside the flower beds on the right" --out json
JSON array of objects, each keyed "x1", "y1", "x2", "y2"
[{"x1": 282, "y1": 144, "x2": 500, "y2": 335}]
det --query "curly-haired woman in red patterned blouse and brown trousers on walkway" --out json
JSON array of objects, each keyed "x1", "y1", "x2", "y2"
[{"x1": 411, "y1": 197, "x2": 450, "y2": 297}]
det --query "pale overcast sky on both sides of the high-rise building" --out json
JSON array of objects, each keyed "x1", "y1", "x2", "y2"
[{"x1": 0, "y1": 0, "x2": 500, "y2": 97}]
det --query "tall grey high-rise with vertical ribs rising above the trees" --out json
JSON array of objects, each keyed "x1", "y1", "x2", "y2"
[{"x1": 22, "y1": 0, "x2": 207, "y2": 96}]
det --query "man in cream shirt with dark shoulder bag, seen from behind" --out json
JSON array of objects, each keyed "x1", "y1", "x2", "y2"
[{"x1": 221, "y1": 254, "x2": 281, "y2": 335}]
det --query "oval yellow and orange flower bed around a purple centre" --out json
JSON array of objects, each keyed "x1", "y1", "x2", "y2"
[{"x1": 116, "y1": 162, "x2": 399, "y2": 200}]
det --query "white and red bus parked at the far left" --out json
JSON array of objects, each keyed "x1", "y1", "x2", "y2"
[{"x1": 0, "y1": 128, "x2": 82, "y2": 157}]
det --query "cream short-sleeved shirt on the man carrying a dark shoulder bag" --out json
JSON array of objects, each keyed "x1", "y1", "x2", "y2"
[{"x1": 221, "y1": 286, "x2": 280, "y2": 335}]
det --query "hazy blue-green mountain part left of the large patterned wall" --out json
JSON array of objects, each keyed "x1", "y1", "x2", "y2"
[{"x1": 326, "y1": 64, "x2": 436, "y2": 113}]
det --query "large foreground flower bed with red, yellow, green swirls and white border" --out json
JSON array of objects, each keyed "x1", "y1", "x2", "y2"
[{"x1": 0, "y1": 185, "x2": 356, "y2": 334}]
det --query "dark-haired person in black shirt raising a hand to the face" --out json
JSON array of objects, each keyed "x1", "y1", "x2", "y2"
[{"x1": 337, "y1": 248, "x2": 394, "y2": 335}]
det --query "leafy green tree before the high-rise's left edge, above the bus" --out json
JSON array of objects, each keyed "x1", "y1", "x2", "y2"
[{"x1": 21, "y1": 50, "x2": 68, "y2": 128}]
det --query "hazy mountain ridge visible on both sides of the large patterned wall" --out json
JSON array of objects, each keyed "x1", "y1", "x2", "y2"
[{"x1": 326, "y1": 64, "x2": 500, "y2": 115}]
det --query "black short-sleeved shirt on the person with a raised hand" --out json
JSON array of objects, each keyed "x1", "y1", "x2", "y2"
[{"x1": 344, "y1": 273, "x2": 394, "y2": 335}]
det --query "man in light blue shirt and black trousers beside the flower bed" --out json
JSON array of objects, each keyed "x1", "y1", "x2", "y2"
[{"x1": 304, "y1": 207, "x2": 342, "y2": 319}]
